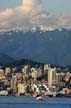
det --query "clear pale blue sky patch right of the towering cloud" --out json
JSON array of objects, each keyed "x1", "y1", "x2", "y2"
[{"x1": 45, "y1": 0, "x2": 71, "y2": 14}]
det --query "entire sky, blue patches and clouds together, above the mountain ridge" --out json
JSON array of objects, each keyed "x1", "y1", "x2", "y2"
[{"x1": 0, "y1": 0, "x2": 71, "y2": 30}]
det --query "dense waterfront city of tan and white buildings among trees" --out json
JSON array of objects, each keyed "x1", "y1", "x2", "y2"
[{"x1": 0, "y1": 64, "x2": 71, "y2": 97}]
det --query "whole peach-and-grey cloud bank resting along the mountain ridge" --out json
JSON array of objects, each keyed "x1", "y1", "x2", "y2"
[{"x1": 0, "y1": 0, "x2": 71, "y2": 30}]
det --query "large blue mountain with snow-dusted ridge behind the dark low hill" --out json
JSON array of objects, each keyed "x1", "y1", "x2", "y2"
[{"x1": 0, "y1": 27, "x2": 71, "y2": 65}]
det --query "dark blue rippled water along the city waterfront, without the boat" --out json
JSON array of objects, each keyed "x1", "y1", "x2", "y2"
[{"x1": 0, "y1": 97, "x2": 71, "y2": 108}]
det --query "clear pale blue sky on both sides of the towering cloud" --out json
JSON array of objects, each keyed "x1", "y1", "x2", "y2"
[{"x1": 0, "y1": 0, "x2": 71, "y2": 14}]
